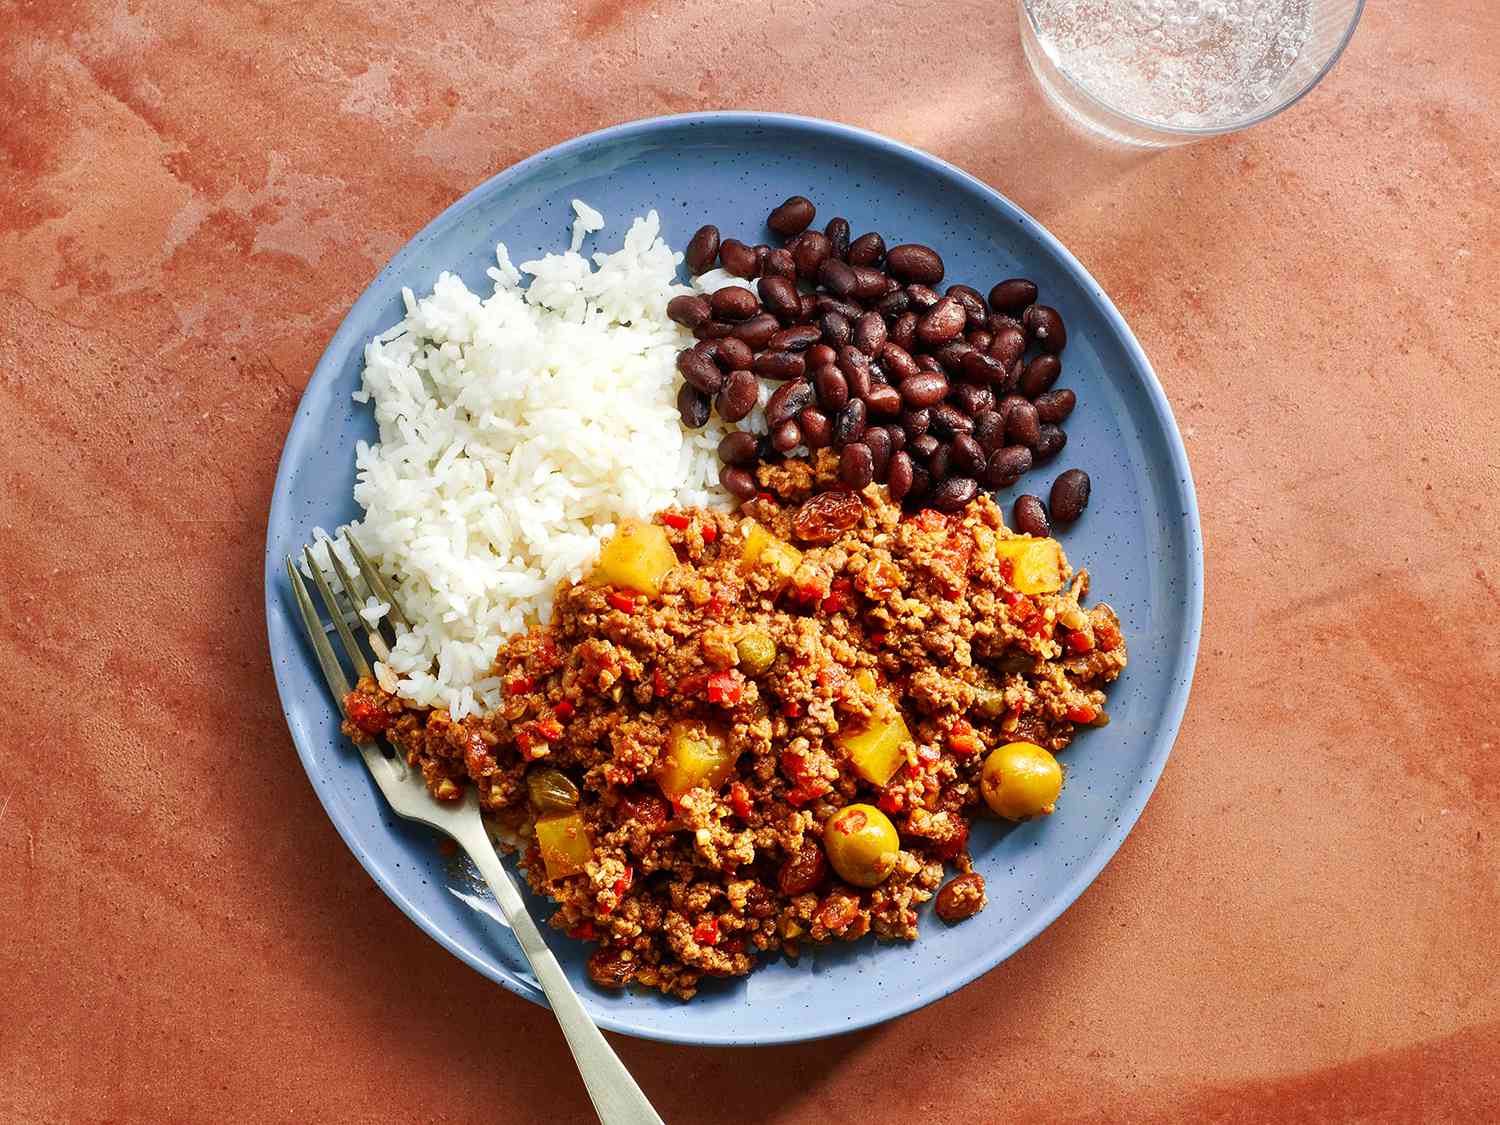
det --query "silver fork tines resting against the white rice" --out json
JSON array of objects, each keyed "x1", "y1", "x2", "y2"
[{"x1": 287, "y1": 528, "x2": 410, "y2": 711}]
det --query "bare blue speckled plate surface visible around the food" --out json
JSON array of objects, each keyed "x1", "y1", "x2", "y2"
[{"x1": 266, "y1": 113, "x2": 1203, "y2": 1044}]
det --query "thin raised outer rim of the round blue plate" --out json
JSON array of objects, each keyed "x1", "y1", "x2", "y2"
[{"x1": 263, "y1": 110, "x2": 1203, "y2": 1047}]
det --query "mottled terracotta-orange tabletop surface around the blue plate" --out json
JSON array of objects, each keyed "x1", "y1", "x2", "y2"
[{"x1": 0, "y1": 0, "x2": 1500, "y2": 1125}]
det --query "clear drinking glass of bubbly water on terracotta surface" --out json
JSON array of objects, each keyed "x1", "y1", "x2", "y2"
[{"x1": 1019, "y1": 0, "x2": 1365, "y2": 147}]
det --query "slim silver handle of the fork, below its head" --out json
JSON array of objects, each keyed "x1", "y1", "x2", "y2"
[{"x1": 458, "y1": 828, "x2": 663, "y2": 1125}]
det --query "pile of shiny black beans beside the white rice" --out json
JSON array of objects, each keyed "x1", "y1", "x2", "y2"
[{"x1": 668, "y1": 195, "x2": 1089, "y2": 534}]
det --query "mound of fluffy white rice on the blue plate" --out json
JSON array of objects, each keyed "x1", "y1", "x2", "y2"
[{"x1": 324, "y1": 200, "x2": 726, "y2": 716}]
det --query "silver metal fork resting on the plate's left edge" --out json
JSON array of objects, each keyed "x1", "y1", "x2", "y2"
[{"x1": 287, "y1": 530, "x2": 663, "y2": 1125}]
